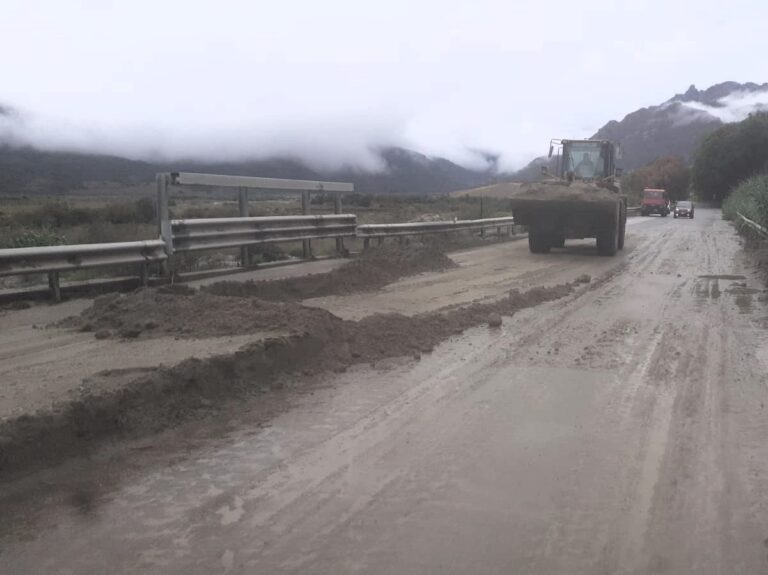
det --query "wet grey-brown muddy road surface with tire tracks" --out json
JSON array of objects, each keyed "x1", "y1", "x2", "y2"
[{"x1": 0, "y1": 209, "x2": 768, "y2": 575}]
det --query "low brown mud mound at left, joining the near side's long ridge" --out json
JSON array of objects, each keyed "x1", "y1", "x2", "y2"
[{"x1": 58, "y1": 288, "x2": 341, "y2": 338}]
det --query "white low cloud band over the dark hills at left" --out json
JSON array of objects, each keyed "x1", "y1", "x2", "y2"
[{"x1": 0, "y1": 108, "x2": 414, "y2": 171}]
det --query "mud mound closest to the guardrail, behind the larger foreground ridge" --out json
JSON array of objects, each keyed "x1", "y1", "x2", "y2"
[{"x1": 203, "y1": 243, "x2": 456, "y2": 301}]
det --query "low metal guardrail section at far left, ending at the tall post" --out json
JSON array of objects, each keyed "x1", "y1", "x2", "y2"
[{"x1": 0, "y1": 240, "x2": 168, "y2": 301}]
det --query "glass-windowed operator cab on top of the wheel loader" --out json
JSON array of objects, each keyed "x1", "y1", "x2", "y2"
[{"x1": 550, "y1": 140, "x2": 619, "y2": 181}]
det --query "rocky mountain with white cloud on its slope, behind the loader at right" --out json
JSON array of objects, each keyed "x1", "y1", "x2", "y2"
[{"x1": 506, "y1": 82, "x2": 768, "y2": 181}]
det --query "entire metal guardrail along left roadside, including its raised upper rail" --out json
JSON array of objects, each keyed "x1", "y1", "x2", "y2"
[{"x1": 0, "y1": 172, "x2": 514, "y2": 301}]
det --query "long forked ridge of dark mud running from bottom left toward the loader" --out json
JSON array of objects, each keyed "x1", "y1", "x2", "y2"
[{"x1": 6, "y1": 282, "x2": 579, "y2": 475}]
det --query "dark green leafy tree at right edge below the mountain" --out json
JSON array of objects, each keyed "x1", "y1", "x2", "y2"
[{"x1": 692, "y1": 112, "x2": 768, "y2": 200}]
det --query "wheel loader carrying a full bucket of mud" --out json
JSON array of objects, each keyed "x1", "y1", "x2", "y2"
[{"x1": 511, "y1": 140, "x2": 627, "y2": 256}]
